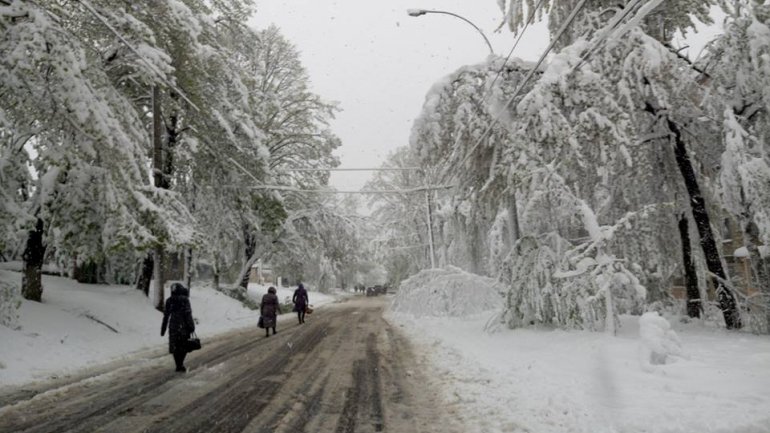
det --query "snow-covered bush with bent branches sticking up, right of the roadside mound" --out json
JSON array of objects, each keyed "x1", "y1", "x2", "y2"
[{"x1": 503, "y1": 182, "x2": 646, "y2": 333}]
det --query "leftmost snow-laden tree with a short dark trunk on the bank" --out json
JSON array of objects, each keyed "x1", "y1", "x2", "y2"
[{"x1": 0, "y1": 1, "x2": 191, "y2": 300}]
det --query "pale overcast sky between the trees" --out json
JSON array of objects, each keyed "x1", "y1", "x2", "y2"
[{"x1": 252, "y1": 0, "x2": 720, "y2": 190}]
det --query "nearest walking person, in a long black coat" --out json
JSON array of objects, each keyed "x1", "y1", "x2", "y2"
[{"x1": 160, "y1": 283, "x2": 195, "y2": 373}]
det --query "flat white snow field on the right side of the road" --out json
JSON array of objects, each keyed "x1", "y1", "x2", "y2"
[{"x1": 388, "y1": 313, "x2": 770, "y2": 433}]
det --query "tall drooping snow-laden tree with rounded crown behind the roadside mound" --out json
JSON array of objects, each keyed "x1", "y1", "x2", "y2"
[{"x1": 410, "y1": 59, "x2": 532, "y2": 274}]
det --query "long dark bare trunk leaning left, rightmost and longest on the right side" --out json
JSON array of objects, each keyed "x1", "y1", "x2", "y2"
[{"x1": 666, "y1": 117, "x2": 741, "y2": 329}]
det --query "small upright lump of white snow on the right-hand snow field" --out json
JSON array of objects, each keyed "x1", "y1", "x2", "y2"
[{"x1": 639, "y1": 311, "x2": 684, "y2": 371}]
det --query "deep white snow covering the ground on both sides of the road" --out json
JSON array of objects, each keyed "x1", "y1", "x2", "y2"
[{"x1": 0, "y1": 264, "x2": 770, "y2": 433}]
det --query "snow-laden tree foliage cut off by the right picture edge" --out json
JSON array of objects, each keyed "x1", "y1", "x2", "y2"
[{"x1": 699, "y1": 1, "x2": 770, "y2": 329}]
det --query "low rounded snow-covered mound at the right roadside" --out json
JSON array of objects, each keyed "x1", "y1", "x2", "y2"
[{"x1": 391, "y1": 266, "x2": 503, "y2": 317}]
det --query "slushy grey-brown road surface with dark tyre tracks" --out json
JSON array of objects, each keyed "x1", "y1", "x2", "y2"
[{"x1": 0, "y1": 298, "x2": 460, "y2": 433}]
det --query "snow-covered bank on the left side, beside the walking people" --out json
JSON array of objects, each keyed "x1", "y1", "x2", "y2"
[{"x1": 0, "y1": 269, "x2": 333, "y2": 386}]
